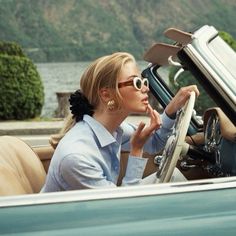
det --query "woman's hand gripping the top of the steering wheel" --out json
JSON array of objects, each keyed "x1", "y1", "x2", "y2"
[{"x1": 165, "y1": 85, "x2": 199, "y2": 117}]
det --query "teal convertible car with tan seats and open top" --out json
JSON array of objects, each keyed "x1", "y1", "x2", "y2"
[{"x1": 0, "y1": 25, "x2": 236, "y2": 236}]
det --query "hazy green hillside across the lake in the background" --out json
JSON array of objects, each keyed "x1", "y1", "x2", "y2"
[{"x1": 0, "y1": 0, "x2": 236, "y2": 62}]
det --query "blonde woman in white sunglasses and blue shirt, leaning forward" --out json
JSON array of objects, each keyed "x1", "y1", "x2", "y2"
[{"x1": 41, "y1": 52, "x2": 199, "y2": 192}]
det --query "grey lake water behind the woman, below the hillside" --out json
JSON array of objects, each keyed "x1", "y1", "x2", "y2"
[{"x1": 36, "y1": 61, "x2": 168, "y2": 117}]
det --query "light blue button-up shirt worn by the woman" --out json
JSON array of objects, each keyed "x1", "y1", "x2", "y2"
[{"x1": 41, "y1": 113, "x2": 174, "y2": 192}]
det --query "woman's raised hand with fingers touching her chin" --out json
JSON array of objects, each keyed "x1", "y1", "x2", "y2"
[{"x1": 130, "y1": 105, "x2": 162, "y2": 156}]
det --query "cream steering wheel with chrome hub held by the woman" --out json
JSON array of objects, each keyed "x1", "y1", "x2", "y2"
[{"x1": 157, "y1": 92, "x2": 195, "y2": 183}]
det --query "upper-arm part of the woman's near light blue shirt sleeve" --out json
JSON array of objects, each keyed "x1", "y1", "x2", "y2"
[{"x1": 59, "y1": 155, "x2": 116, "y2": 190}]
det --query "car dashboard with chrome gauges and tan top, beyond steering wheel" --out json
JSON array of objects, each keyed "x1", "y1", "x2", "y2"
[{"x1": 179, "y1": 107, "x2": 236, "y2": 179}]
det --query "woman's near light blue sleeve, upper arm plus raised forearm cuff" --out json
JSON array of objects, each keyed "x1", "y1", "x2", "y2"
[{"x1": 60, "y1": 155, "x2": 147, "y2": 190}]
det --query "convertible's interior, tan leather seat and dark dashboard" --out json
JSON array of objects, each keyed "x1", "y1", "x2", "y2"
[{"x1": 0, "y1": 108, "x2": 236, "y2": 196}]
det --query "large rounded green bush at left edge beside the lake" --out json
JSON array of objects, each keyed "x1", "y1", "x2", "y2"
[{"x1": 0, "y1": 42, "x2": 44, "y2": 120}]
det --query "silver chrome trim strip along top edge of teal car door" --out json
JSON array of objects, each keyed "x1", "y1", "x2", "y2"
[{"x1": 0, "y1": 177, "x2": 236, "y2": 208}]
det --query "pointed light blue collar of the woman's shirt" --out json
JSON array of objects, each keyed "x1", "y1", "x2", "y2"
[{"x1": 83, "y1": 115, "x2": 123, "y2": 147}]
